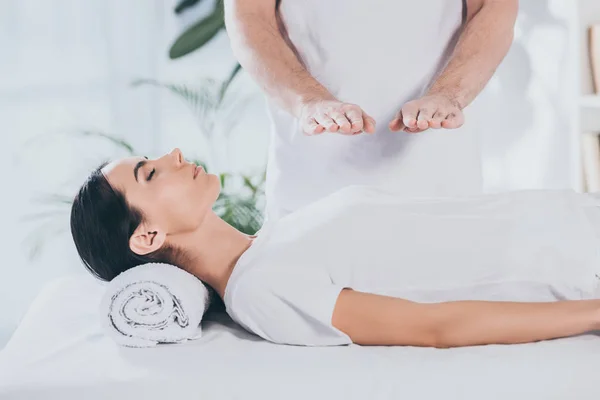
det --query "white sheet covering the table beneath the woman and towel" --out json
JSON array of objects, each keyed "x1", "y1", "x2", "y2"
[{"x1": 0, "y1": 278, "x2": 600, "y2": 400}]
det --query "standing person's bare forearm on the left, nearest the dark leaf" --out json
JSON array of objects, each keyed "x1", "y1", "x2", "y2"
[{"x1": 225, "y1": 0, "x2": 334, "y2": 117}]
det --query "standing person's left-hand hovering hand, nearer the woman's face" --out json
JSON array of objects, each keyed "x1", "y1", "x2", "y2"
[{"x1": 299, "y1": 100, "x2": 375, "y2": 135}]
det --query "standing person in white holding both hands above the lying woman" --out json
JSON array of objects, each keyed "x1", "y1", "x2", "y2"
[{"x1": 225, "y1": 0, "x2": 518, "y2": 219}]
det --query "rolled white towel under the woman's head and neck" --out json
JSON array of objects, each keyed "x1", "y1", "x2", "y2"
[{"x1": 100, "y1": 263, "x2": 210, "y2": 347}]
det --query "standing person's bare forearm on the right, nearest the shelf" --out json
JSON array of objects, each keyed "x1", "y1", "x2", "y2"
[{"x1": 428, "y1": 0, "x2": 518, "y2": 109}]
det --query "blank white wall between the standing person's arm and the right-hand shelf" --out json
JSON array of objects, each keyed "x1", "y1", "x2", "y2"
[{"x1": 470, "y1": 0, "x2": 580, "y2": 192}]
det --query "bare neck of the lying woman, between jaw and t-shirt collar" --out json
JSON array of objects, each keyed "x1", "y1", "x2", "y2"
[{"x1": 171, "y1": 212, "x2": 253, "y2": 298}]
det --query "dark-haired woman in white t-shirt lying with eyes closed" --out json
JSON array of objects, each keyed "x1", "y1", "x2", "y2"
[{"x1": 71, "y1": 149, "x2": 600, "y2": 348}]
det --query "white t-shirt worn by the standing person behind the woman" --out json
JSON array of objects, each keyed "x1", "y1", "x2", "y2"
[{"x1": 266, "y1": 0, "x2": 481, "y2": 219}]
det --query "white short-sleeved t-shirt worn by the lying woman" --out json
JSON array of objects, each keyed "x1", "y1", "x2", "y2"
[{"x1": 224, "y1": 186, "x2": 600, "y2": 346}]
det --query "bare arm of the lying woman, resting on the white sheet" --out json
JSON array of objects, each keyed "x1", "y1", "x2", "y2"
[{"x1": 332, "y1": 289, "x2": 600, "y2": 348}]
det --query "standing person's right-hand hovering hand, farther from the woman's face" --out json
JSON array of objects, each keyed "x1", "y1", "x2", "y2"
[{"x1": 389, "y1": 94, "x2": 465, "y2": 133}]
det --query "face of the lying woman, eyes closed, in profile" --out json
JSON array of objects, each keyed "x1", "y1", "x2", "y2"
[{"x1": 102, "y1": 149, "x2": 220, "y2": 238}]
